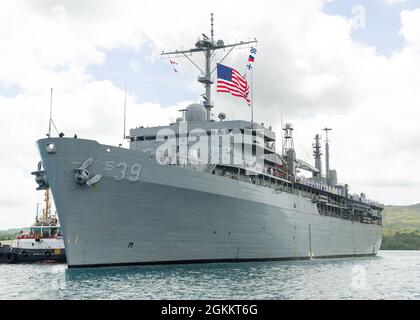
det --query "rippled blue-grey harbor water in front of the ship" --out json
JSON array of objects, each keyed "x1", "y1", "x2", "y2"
[{"x1": 0, "y1": 251, "x2": 420, "y2": 300}]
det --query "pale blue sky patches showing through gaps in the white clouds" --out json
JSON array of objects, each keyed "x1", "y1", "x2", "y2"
[{"x1": 81, "y1": 0, "x2": 420, "y2": 106}]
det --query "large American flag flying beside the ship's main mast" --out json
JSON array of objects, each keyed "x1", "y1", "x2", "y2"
[{"x1": 217, "y1": 63, "x2": 251, "y2": 105}]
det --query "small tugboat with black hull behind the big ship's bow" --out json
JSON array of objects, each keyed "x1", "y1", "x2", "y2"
[{"x1": 0, "y1": 189, "x2": 66, "y2": 263}]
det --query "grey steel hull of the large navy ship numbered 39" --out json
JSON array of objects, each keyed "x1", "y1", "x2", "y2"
[{"x1": 38, "y1": 138, "x2": 382, "y2": 267}]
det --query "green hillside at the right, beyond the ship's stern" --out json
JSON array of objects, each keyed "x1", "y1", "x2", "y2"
[{"x1": 381, "y1": 203, "x2": 420, "y2": 250}]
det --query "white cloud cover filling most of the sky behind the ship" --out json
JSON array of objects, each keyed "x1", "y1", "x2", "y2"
[{"x1": 0, "y1": 0, "x2": 420, "y2": 228}]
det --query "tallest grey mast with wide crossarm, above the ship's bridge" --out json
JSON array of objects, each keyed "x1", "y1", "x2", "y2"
[{"x1": 161, "y1": 13, "x2": 257, "y2": 120}]
